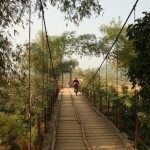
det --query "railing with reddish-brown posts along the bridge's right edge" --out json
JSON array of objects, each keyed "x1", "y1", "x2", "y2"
[{"x1": 79, "y1": 84, "x2": 150, "y2": 150}]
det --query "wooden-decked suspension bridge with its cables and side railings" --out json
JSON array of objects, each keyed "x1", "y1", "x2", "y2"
[{"x1": 24, "y1": 1, "x2": 148, "y2": 150}]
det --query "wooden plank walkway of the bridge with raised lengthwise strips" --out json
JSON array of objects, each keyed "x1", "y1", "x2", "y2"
[{"x1": 55, "y1": 88, "x2": 134, "y2": 150}]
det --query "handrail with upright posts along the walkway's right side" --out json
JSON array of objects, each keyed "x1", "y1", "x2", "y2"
[{"x1": 79, "y1": 86, "x2": 150, "y2": 150}]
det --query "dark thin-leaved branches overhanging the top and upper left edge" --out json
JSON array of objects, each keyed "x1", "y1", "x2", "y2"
[{"x1": 0, "y1": 0, "x2": 102, "y2": 99}]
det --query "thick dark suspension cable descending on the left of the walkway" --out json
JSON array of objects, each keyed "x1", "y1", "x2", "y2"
[{"x1": 40, "y1": 0, "x2": 57, "y2": 85}]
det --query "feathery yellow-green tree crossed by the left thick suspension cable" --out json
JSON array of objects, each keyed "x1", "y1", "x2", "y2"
[{"x1": 29, "y1": 32, "x2": 78, "y2": 77}]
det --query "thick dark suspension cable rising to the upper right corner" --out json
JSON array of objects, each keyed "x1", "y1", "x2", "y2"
[{"x1": 85, "y1": 0, "x2": 139, "y2": 87}]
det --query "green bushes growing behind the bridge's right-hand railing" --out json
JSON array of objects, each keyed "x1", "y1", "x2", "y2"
[{"x1": 79, "y1": 67, "x2": 150, "y2": 150}]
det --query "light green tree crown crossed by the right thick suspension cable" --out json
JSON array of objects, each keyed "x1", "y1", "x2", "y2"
[{"x1": 99, "y1": 18, "x2": 133, "y2": 69}]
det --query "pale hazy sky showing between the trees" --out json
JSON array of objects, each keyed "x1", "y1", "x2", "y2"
[{"x1": 16, "y1": 0, "x2": 150, "y2": 69}]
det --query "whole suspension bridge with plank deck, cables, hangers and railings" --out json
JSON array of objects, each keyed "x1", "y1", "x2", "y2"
[{"x1": 0, "y1": 0, "x2": 149, "y2": 150}]
